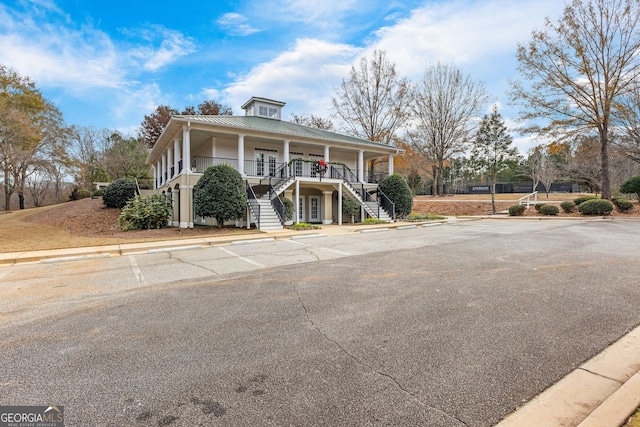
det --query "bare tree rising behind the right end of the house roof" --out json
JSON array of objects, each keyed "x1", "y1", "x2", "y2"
[{"x1": 331, "y1": 50, "x2": 410, "y2": 176}]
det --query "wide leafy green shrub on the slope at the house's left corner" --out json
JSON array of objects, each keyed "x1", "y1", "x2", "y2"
[{"x1": 118, "y1": 194, "x2": 171, "y2": 231}]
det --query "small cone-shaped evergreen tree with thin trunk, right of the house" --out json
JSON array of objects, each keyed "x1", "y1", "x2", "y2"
[{"x1": 471, "y1": 105, "x2": 518, "y2": 213}]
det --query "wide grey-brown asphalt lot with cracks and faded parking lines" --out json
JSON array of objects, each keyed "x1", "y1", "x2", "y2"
[{"x1": 0, "y1": 220, "x2": 640, "y2": 426}]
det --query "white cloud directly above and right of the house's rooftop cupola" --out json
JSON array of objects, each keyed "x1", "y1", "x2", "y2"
[{"x1": 222, "y1": 39, "x2": 360, "y2": 118}]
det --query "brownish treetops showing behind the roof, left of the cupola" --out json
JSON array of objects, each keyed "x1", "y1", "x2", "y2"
[{"x1": 138, "y1": 100, "x2": 233, "y2": 148}]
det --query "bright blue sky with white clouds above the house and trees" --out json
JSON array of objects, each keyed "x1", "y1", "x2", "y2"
[{"x1": 0, "y1": 0, "x2": 564, "y2": 151}]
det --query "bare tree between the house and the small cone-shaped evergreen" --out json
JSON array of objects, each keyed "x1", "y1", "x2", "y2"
[{"x1": 408, "y1": 63, "x2": 488, "y2": 196}]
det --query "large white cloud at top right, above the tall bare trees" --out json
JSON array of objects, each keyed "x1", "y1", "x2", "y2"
[{"x1": 371, "y1": 0, "x2": 563, "y2": 77}]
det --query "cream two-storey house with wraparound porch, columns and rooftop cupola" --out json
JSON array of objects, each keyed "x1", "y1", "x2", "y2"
[{"x1": 147, "y1": 97, "x2": 402, "y2": 230}]
